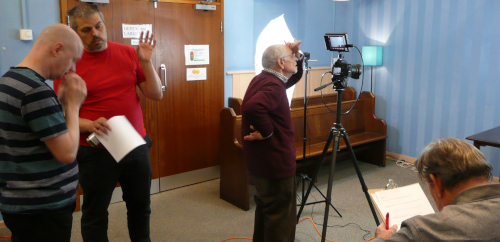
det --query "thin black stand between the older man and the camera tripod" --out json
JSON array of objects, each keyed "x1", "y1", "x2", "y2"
[{"x1": 296, "y1": 52, "x2": 342, "y2": 217}]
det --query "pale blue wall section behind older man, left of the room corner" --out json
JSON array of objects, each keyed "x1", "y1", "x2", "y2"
[{"x1": 224, "y1": 0, "x2": 335, "y2": 105}]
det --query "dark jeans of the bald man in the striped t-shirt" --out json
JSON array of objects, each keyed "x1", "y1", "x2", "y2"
[{"x1": 2, "y1": 202, "x2": 76, "y2": 242}]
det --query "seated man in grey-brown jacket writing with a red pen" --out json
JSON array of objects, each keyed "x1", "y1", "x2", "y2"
[{"x1": 373, "y1": 139, "x2": 500, "y2": 241}]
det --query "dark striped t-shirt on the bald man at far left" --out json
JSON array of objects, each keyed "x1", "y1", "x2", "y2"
[{"x1": 0, "y1": 67, "x2": 78, "y2": 213}]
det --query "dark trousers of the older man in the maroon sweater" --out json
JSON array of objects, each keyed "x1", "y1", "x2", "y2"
[{"x1": 250, "y1": 176, "x2": 297, "y2": 242}]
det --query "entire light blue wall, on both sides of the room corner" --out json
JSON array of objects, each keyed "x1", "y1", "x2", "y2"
[{"x1": 225, "y1": 0, "x2": 500, "y2": 175}]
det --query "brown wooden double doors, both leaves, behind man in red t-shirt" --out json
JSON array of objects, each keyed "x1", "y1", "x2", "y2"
[{"x1": 60, "y1": 0, "x2": 224, "y2": 192}]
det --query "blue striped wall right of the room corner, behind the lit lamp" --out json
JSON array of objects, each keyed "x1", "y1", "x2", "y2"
[{"x1": 335, "y1": 0, "x2": 500, "y2": 176}]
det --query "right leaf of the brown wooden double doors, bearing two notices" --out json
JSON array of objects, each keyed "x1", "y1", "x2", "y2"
[{"x1": 155, "y1": 1, "x2": 224, "y2": 190}]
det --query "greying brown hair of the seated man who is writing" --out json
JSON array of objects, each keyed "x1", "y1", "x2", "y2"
[{"x1": 415, "y1": 139, "x2": 493, "y2": 189}]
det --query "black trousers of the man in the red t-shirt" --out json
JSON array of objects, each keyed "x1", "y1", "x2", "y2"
[{"x1": 77, "y1": 135, "x2": 152, "y2": 242}]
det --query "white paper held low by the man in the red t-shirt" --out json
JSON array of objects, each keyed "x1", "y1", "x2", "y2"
[{"x1": 96, "y1": 115, "x2": 146, "y2": 162}]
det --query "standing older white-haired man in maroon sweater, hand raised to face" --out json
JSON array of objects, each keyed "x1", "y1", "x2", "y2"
[{"x1": 241, "y1": 41, "x2": 303, "y2": 242}]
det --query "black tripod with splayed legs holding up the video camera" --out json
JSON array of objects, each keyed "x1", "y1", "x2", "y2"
[{"x1": 297, "y1": 78, "x2": 379, "y2": 242}]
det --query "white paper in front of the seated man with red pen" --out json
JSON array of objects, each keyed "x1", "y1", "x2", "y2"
[{"x1": 372, "y1": 183, "x2": 434, "y2": 230}]
